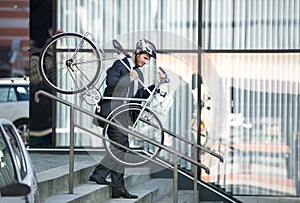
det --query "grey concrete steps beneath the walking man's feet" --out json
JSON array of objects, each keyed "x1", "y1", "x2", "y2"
[{"x1": 37, "y1": 151, "x2": 193, "y2": 203}]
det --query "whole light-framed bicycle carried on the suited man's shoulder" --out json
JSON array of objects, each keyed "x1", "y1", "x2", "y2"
[{"x1": 40, "y1": 30, "x2": 170, "y2": 166}]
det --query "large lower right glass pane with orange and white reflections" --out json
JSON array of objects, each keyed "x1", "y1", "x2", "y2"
[{"x1": 201, "y1": 53, "x2": 300, "y2": 195}]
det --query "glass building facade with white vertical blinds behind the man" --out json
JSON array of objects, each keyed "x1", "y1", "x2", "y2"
[{"x1": 45, "y1": 0, "x2": 300, "y2": 196}]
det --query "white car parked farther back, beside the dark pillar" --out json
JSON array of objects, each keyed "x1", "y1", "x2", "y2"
[{"x1": 0, "y1": 78, "x2": 29, "y2": 145}]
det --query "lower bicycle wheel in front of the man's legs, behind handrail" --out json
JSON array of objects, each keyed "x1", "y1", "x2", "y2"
[{"x1": 103, "y1": 104, "x2": 164, "y2": 167}]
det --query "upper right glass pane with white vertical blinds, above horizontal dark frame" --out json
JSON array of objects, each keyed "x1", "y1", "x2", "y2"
[{"x1": 201, "y1": 0, "x2": 300, "y2": 50}]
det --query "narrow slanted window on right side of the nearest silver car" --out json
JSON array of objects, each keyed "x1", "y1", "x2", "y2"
[{"x1": 3, "y1": 125, "x2": 27, "y2": 178}]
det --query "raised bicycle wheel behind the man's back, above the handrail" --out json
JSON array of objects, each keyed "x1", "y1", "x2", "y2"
[{"x1": 40, "y1": 33, "x2": 102, "y2": 94}]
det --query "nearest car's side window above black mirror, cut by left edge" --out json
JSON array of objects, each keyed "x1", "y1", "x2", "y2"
[{"x1": 0, "y1": 130, "x2": 17, "y2": 187}]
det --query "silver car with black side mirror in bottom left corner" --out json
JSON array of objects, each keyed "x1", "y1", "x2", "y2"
[{"x1": 0, "y1": 119, "x2": 40, "y2": 203}]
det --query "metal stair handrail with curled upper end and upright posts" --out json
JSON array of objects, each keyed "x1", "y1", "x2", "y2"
[{"x1": 34, "y1": 90, "x2": 232, "y2": 202}]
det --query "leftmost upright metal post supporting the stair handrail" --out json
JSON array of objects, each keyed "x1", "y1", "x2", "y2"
[{"x1": 69, "y1": 105, "x2": 74, "y2": 194}]
